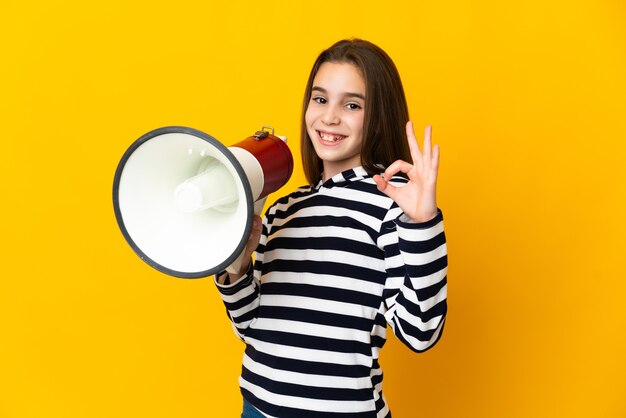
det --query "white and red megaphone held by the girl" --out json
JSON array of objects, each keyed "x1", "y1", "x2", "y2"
[{"x1": 113, "y1": 126, "x2": 293, "y2": 278}]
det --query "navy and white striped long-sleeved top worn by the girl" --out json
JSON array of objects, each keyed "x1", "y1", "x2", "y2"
[{"x1": 216, "y1": 167, "x2": 447, "y2": 418}]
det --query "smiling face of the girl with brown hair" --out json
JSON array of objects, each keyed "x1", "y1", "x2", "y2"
[{"x1": 305, "y1": 62, "x2": 365, "y2": 180}]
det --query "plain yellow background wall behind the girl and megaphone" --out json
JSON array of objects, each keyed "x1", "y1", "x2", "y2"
[{"x1": 0, "y1": 0, "x2": 626, "y2": 418}]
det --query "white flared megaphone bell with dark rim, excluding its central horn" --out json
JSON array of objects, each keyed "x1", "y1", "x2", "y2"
[{"x1": 113, "y1": 127, "x2": 254, "y2": 278}]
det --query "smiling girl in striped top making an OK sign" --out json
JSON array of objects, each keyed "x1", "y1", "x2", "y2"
[{"x1": 216, "y1": 39, "x2": 447, "y2": 418}]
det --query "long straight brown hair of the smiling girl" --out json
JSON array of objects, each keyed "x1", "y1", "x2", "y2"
[{"x1": 300, "y1": 39, "x2": 411, "y2": 184}]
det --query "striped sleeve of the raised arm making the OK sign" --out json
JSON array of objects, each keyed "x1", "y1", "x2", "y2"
[{"x1": 380, "y1": 208, "x2": 448, "y2": 352}]
